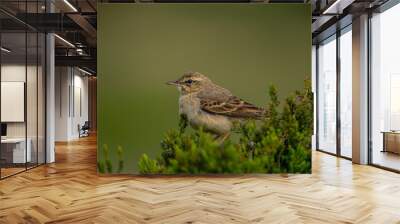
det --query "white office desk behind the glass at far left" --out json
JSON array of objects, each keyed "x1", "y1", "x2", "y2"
[{"x1": 1, "y1": 138, "x2": 32, "y2": 163}]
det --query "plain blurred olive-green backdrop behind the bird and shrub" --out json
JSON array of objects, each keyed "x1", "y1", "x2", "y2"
[{"x1": 98, "y1": 3, "x2": 311, "y2": 173}]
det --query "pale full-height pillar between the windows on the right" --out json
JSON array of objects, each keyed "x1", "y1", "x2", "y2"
[{"x1": 352, "y1": 15, "x2": 368, "y2": 164}]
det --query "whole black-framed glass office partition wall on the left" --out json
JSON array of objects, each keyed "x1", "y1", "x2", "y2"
[{"x1": 0, "y1": 1, "x2": 46, "y2": 179}]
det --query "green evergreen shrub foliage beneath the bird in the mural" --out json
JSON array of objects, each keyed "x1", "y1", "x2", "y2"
[{"x1": 138, "y1": 80, "x2": 313, "y2": 174}]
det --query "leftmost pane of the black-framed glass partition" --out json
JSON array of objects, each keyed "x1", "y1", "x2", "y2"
[{"x1": 0, "y1": 32, "x2": 27, "y2": 178}]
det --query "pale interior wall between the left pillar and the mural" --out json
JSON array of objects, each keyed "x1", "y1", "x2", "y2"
[{"x1": 55, "y1": 67, "x2": 89, "y2": 141}]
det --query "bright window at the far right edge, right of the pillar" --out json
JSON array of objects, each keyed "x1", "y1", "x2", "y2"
[{"x1": 370, "y1": 1, "x2": 400, "y2": 170}]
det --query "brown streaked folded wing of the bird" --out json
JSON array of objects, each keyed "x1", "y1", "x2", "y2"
[{"x1": 200, "y1": 96, "x2": 265, "y2": 119}]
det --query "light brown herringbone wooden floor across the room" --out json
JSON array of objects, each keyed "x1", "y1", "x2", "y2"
[{"x1": 0, "y1": 138, "x2": 400, "y2": 224}]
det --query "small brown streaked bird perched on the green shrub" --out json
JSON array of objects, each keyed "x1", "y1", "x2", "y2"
[{"x1": 167, "y1": 72, "x2": 266, "y2": 142}]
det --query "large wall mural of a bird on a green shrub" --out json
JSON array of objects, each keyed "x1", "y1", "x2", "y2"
[{"x1": 98, "y1": 4, "x2": 313, "y2": 174}]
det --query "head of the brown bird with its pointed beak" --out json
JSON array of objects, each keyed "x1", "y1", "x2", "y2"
[{"x1": 167, "y1": 72, "x2": 212, "y2": 94}]
